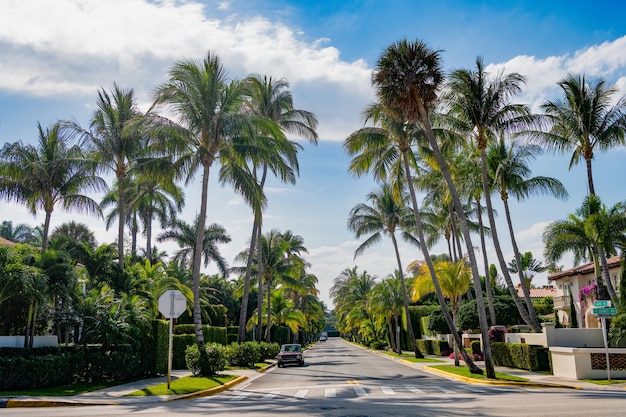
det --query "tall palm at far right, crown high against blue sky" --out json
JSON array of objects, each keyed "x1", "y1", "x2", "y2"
[{"x1": 527, "y1": 74, "x2": 626, "y2": 194}]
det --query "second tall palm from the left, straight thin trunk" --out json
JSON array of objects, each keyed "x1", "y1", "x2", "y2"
[{"x1": 68, "y1": 83, "x2": 147, "y2": 271}]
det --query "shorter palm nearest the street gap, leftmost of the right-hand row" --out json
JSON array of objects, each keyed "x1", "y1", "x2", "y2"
[{"x1": 348, "y1": 184, "x2": 424, "y2": 358}]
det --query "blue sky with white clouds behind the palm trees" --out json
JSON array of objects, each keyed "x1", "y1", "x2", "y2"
[{"x1": 0, "y1": 0, "x2": 626, "y2": 307}]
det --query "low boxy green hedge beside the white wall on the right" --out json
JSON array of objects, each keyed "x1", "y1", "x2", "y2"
[{"x1": 491, "y1": 342, "x2": 550, "y2": 371}]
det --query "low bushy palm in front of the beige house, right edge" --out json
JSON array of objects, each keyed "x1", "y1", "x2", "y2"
[{"x1": 543, "y1": 194, "x2": 626, "y2": 303}]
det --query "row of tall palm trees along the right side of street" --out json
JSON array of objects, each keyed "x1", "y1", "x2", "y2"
[{"x1": 344, "y1": 40, "x2": 626, "y2": 378}]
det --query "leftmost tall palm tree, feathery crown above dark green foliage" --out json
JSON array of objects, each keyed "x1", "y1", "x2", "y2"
[{"x1": 0, "y1": 123, "x2": 106, "y2": 252}]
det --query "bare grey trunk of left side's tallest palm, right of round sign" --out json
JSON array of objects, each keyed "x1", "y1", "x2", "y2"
[{"x1": 192, "y1": 164, "x2": 210, "y2": 350}]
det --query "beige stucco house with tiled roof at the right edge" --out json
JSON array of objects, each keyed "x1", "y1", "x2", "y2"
[{"x1": 548, "y1": 256, "x2": 622, "y2": 328}]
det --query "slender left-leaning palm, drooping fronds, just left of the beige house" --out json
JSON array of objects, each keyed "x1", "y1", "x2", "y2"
[{"x1": 487, "y1": 138, "x2": 568, "y2": 322}]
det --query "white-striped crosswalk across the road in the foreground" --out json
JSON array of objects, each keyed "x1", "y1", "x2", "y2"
[{"x1": 206, "y1": 382, "x2": 525, "y2": 402}]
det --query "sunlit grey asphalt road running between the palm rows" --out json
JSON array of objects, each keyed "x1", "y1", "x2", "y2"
[{"x1": 0, "y1": 338, "x2": 626, "y2": 417}]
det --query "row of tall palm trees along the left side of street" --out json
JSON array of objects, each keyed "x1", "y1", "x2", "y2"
[{"x1": 0, "y1": 52, "x2": 317, "y2": 346}]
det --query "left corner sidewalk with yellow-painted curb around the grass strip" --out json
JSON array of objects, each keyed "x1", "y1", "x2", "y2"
[{"x1": 0, "y1": 365, "x2": 266, "y2": 408}]
